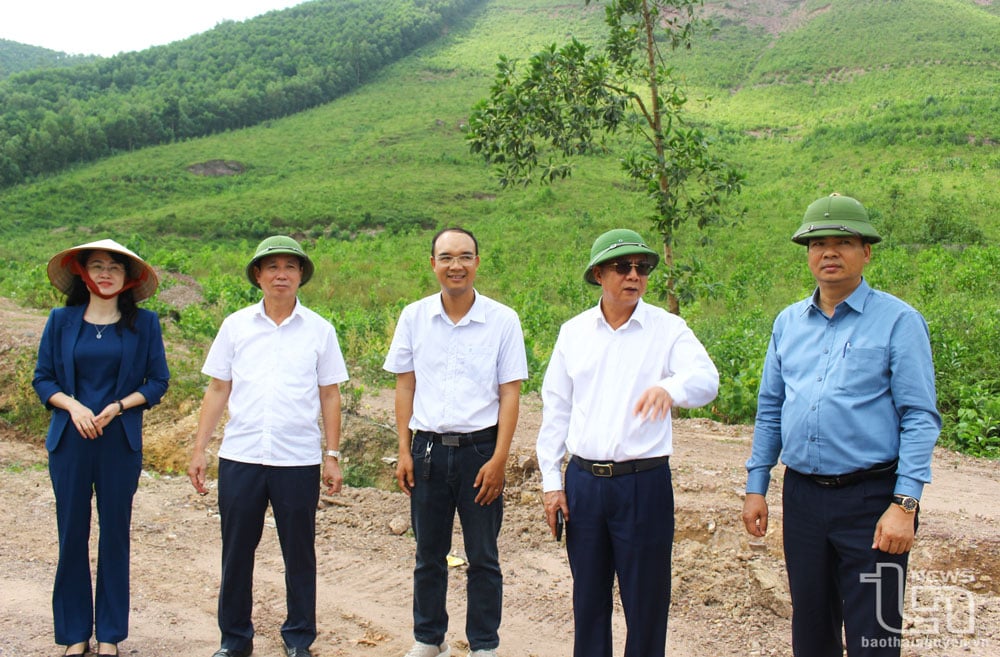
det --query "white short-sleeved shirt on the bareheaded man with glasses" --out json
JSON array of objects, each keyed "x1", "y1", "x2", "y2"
[{"x1": 383, "y1": 292, "x2": 528, "y2": 433}]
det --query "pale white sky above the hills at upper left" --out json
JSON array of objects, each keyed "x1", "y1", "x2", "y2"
[{"x1": 0, "y1": 0, "x2": 303, "y2": 57}]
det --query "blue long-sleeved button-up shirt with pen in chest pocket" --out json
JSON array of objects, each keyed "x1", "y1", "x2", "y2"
[{"x1": 747, "y1": 280, "x2": 941, "y2": 499}]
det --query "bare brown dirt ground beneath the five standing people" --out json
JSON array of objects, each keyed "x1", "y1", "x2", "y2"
[{"x1": 0, "y1": 300, "x2": 1000, "y2": 657}]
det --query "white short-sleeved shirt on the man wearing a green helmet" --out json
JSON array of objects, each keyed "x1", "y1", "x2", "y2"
[{"x1": 201, "y1": 301, "x2": 348, "y2": 466}]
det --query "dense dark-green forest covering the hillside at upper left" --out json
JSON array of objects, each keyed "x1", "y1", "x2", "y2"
[{"x1": 0, "y1": 0, "x2": 482, "y2": 187}]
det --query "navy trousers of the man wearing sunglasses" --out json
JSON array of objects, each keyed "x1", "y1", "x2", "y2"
[{"x1": 566, "y1": 461, "x2": 674, "y2": 657}]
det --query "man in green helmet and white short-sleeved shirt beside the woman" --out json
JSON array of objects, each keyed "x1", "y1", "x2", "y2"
[{"x1": 188, "y1": 235, "x2": 347, "y2": 657}]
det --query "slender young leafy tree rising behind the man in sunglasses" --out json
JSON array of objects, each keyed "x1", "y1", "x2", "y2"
[{"x1": 468, "y1": 0, "x2": 743, "y2": 314}]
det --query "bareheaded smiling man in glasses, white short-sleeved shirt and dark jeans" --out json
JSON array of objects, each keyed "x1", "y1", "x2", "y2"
[{"x1": 383, "y1": 228, "x2": 528, "y2": 657}]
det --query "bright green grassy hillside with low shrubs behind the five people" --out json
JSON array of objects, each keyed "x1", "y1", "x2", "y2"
[{"x1": 0, "y1": 0, "x2": 1000, "y2": 456}]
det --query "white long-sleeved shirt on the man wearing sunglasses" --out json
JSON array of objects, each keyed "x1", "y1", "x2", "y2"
[{"x1": 537, "y1": 299, "x2": 719, "y2": 492}]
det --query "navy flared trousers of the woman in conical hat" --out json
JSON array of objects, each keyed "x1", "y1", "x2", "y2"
[{"x1": 49, "y1": 422, "x2": 142, "y2": 645}]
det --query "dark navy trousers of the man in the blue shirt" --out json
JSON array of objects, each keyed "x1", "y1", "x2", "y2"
[{"x1": 783, "y1": 469, "x2": 910, "y2": 657}]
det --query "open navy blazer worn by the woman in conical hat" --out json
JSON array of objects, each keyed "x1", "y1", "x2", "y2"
[{"x1": 31, "y1": 305, "x2": 170, "y2": 452}]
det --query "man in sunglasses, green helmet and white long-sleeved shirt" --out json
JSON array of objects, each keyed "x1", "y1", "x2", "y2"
[{"x1": 537, "y1": 229, "x2": 719, "y2": 657}]
